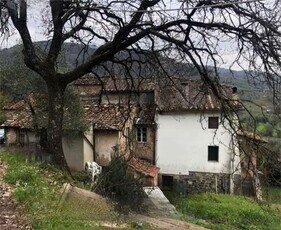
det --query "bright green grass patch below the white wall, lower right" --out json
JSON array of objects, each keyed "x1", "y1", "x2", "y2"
[{"x1": 177, "y1": 193, "x2": 281, "y2": 230}]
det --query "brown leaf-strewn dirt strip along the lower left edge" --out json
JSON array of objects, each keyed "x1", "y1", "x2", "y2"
[{"x1": 0, "y1": 155, "x2": 31, "y2": 230}]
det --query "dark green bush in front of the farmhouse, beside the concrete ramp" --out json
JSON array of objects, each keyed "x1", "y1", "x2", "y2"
[{"x1": 93, "y1": 155, "x2": 145, "y2": 211}]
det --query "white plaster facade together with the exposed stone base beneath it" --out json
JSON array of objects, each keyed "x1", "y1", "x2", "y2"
[{"x1": 156, "y1": 112, "x2": 240, "y2": 193}]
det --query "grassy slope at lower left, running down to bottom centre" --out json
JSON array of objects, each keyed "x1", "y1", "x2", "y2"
[{"x1": 0, "y1": 152, "x2": 158, "y2": 230}]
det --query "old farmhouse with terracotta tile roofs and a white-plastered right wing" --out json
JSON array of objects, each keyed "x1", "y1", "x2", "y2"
[{"x1": 3, "y1": 75, "x2": 241, "y2": 193}]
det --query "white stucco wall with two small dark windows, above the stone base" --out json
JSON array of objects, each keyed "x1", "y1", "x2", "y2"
[{"x1": 156, "y1": 113, "x2": 233, "y2": 175}]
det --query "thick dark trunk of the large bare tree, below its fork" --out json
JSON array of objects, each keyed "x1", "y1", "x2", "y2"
[{"x1": 43, "y1": 81, "x2": 69, "y2": 171}]
